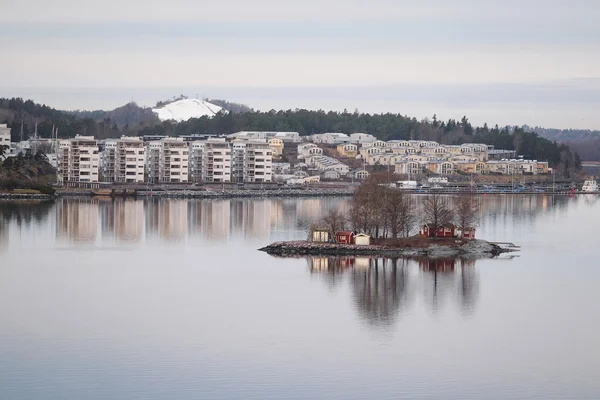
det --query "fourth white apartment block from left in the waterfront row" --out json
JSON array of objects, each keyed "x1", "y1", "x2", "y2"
[{"x1": 190, "y1": 138, "x2": 232, "y2": 183}]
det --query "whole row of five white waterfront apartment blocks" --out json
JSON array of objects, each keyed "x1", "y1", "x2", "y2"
[{"x1": 57, "y1": 136, "x2": 273, "y2": 185}]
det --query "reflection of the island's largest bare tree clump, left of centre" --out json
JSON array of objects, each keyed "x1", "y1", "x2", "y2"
[{"x1": 351, "y1": 259, "x2": 408, "y2": 327}]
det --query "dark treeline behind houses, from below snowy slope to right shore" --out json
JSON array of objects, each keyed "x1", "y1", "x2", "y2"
[{"x1": 139, "y1": 110, "x2": 581, "y2": 175}]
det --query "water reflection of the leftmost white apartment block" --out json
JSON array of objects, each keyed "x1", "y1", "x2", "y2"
[{"x1": 56, "y1": 199, "x2": 99, "y2": 243}]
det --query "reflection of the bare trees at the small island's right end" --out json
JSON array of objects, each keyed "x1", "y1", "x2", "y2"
[{"x1": 417, "y1": 258, "x2": 479, "y2": 314}]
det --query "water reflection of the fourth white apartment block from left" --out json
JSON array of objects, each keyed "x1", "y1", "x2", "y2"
[{"x1": 189, "y1": 200, "x2": 231, "y2": 240}]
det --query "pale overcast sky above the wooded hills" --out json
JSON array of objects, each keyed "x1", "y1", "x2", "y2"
[{"x1": 0, "y1": 0, "x2": 600, "y2": 129}]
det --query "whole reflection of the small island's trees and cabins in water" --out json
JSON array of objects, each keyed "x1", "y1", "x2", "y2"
[{"x1": 307, "y1": 257, "x2": 486, "y2": 327}]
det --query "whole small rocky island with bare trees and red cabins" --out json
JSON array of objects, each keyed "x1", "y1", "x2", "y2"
[{"x1": 259, "y1": 179, "x2": 519, "y2": 257}]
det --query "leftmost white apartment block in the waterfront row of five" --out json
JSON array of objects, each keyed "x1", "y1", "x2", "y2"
[{"x1": 56, "y1": 135, "x2": 100, "y2": 185}]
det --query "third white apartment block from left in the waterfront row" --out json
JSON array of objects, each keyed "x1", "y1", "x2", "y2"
[{"x1": 146, "y1": 138, "x2": 189, "y2": 183}]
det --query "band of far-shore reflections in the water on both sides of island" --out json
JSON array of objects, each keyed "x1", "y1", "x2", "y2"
[{"x1": 0, "y1": 195, "x2": 598, "y2": 246}]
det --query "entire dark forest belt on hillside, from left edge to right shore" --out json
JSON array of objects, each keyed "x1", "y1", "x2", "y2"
[{"x1": 0, "y1": 98, "x2": 581, "y2": 174}]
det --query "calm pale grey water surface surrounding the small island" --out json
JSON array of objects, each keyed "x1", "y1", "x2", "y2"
[{"x1": 0, "y1": 196, "x2": 600, "y2": 400}]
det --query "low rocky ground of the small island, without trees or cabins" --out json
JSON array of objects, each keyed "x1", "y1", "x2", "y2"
[{"x1": 258, "y1": 239, "x2": 516, "y2": 257}]
